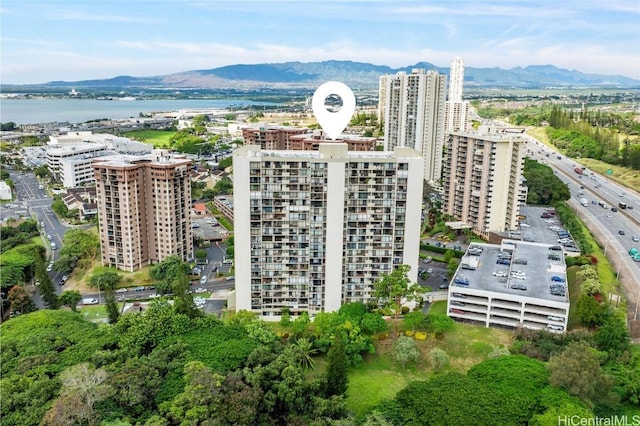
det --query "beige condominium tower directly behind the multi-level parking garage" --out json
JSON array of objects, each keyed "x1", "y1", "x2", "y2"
[{"x1": 443, "y1": 129, "x2": 526, "y2": 237}]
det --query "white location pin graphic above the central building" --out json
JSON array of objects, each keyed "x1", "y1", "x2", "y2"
[{"x1": 311, "y1": 81, "x2": 356, "y2": 140}]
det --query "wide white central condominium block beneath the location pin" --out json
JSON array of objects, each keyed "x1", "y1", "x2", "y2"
[{"x1": 233, "y1": 143, "x2": 423, "y2": 320}]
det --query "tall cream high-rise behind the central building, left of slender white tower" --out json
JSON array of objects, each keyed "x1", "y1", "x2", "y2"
[{"x1": 379, "y1": 69, "x2": 446, "y2": 187}]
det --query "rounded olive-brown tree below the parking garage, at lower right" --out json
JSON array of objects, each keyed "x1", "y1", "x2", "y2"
[{"x1": 547, "y1": 341, "x2": 611, "y2": 403}]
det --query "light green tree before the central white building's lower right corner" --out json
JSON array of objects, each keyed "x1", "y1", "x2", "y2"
[{"x1": 373, "y1": 265, "x2": 422, "y2": 333}]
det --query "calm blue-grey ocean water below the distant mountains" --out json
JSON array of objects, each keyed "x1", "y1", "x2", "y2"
[{"x1": 0, "y1": 98, "x2": 274, "y2": 125}]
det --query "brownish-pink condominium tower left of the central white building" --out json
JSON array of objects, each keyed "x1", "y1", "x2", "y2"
[{"x1": 93, "y1": 155, "x2": 193, "y2": 271}]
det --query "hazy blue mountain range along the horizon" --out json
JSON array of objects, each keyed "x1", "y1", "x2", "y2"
[{"x1": 37, "y1": 61, "x2": 640, "y2": 89}]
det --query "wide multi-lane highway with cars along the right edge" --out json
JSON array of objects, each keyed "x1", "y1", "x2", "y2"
[{"x1": 524, "y1": 135, "x2": 640, "y2": 332}]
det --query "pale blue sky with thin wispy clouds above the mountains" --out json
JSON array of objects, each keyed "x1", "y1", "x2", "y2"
[{"x1": 0, "y1": 0, "x2": 640, "y2": 84}]
